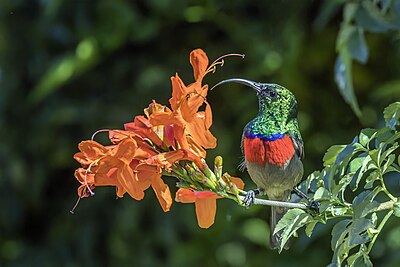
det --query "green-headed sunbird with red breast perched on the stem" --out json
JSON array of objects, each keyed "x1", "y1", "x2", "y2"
[{"x1": 214, "y1": 78, "x2": 304, "y2": 249}]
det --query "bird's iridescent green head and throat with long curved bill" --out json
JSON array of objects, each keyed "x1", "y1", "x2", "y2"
[{"x1": 213, "y1": 78, "x2": 301, "y2": 138}]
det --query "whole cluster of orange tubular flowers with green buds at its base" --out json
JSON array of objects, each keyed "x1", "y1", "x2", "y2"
[{"x1": 74, "y1": 49, "x2": 244, "y2": 228}]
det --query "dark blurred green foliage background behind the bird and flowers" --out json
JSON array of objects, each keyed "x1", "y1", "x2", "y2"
[{"x1": 0, "y1": 0, "x2": 400, "y2": 267}]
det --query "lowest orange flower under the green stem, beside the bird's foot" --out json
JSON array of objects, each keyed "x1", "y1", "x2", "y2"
[{"x1": 175, "y1": 177, "x2": 244, "y2": 228}]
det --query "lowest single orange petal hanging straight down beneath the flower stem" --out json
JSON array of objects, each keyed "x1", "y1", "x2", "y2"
[{"x1": 195, "y1": 198, "x2": 217, "y2": 228}]
